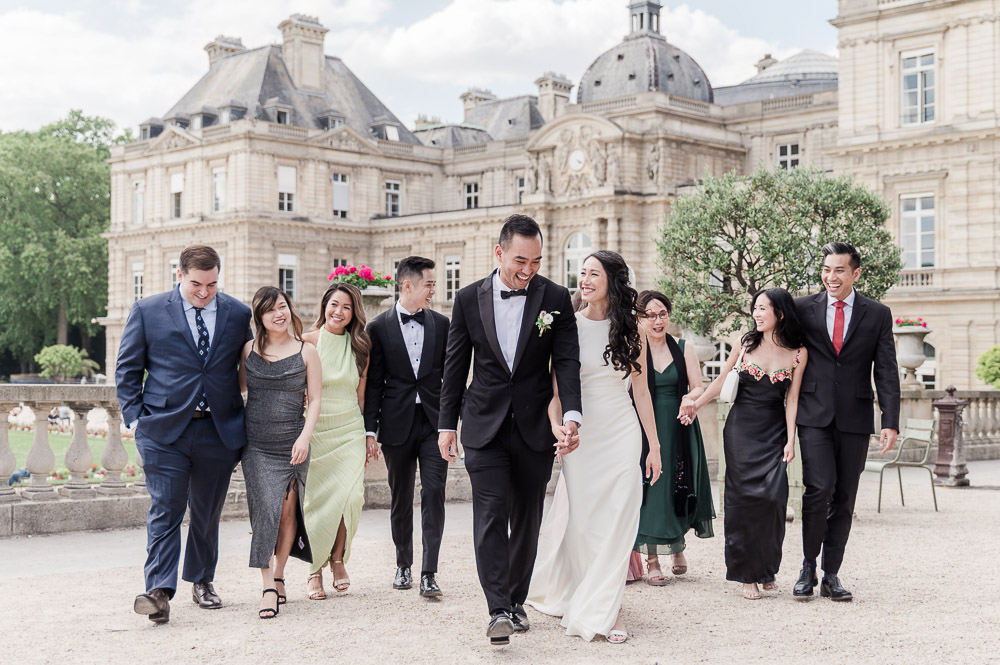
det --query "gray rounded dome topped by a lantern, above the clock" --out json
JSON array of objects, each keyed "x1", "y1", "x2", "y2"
[{"x1": 576, "y1": 2, "x2": 714, "y2": 104}]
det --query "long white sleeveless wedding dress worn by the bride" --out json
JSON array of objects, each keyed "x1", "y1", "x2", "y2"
[{"x1": 527, "y1": 314, "x2": 642, "y2": 640}]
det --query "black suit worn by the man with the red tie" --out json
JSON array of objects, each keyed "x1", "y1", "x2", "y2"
[{"x1": 795, "y1": 291, "x2": 899, "y2": 575}]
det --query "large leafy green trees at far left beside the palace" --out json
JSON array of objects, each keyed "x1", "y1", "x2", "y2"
[{"x1": 0, "y1": 111, "x2": 131, "y2": 363}]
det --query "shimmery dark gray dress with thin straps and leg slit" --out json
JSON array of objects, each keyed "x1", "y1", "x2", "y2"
[{"x1": 243, "y1": 348, "x2": 312, "y2": 568}]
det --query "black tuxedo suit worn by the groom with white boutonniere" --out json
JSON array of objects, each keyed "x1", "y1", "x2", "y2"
[{"x1": 438, "y1": 275, "x2": 582, "y2": 612}]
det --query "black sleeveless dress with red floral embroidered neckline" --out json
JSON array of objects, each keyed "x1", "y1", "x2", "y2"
[{"x1": 722, "y1": 355, "x2": 799, "y2": 584}]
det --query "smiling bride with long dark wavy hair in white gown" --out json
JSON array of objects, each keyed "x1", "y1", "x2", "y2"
[{"x1": 527, "y1": 250, "x2": 660, "y2": 644}]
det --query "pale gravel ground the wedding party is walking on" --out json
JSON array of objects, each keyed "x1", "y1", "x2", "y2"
[{"x1": 0, "y1": 462, "x2": 1000, "y2": 665}]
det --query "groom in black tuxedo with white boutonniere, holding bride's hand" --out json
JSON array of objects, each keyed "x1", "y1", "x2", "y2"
[{"x1": 438, "y1": 215, "x2": 582, "y2": 644}]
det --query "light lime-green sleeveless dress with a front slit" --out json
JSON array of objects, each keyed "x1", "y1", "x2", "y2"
[{"x1": 304, "y1": 328, "x2": 366, "y2": 573}]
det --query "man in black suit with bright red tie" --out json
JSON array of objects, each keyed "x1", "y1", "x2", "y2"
[{"x1": 792, "y1": 242, "x2": 899, "y2": 601}]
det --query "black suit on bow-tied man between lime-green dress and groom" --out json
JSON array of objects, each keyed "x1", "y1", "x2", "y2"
[{"x1": 365, "y1": 306, "x2": 448, "y2": 574}]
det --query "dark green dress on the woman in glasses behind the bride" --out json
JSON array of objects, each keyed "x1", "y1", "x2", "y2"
[{"x1": 635, "y1": 339, "x2": 715, "y2": 555}]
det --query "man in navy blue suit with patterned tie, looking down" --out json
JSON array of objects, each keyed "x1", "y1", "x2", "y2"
[{"x1": 115, "y1": 245, "x2": 252, "y2": 623}]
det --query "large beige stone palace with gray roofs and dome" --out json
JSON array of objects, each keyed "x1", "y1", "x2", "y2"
[{"x1": 102, "y1": 0, "x2": 1000, "y2": 388}]
